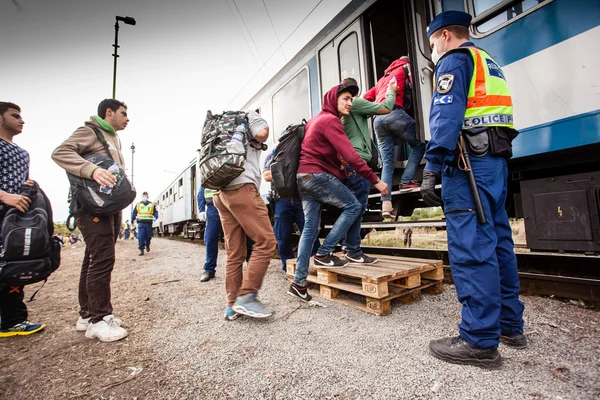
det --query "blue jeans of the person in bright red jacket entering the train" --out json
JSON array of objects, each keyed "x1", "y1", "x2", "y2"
[{"x1": 374, "y1": 108, "x2": 425, "y2": 200}]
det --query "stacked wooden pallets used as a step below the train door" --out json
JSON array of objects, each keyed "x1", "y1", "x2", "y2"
[{"x1": 287, "y1": 256, "x2": 444, "y2": 315}]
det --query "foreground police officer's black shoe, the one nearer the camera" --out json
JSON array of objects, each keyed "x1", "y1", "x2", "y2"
[{"x1": 429, "y1": 336, "x2": 502, "y2": 369}]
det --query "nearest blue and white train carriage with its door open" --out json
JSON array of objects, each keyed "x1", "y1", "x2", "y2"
[{"x1": 156, "y1": 0, "x2": 600, "y2": 252}]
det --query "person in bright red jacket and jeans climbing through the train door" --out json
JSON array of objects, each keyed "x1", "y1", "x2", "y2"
[{"x1": 364, "y1": 56, "x2": 425, "y2": 218}]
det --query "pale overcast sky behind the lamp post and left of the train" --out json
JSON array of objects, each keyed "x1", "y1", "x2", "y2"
[{"x1": 0, "y1": 0, "x2": 350, "y2": 221}]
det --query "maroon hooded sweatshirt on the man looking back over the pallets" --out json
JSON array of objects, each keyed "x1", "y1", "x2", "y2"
[{"x1": 298, "y1": 86, "x2": 378, "y2": 183}]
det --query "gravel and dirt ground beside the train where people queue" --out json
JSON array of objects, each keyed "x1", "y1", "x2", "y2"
[{"x1": 0, "y1": 238, "x2": 600, "y2": 399}]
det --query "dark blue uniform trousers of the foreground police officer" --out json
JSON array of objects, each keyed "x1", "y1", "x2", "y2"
[{"x1": 442, "y1": 155, "x2": 524, "y2": 348}]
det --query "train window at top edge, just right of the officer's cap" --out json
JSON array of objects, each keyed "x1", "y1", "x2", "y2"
[{"x1": 469, "y1": 0, "x2": 553, "y2": 37}]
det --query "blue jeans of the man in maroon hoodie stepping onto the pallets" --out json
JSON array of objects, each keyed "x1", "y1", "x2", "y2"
[{"x1": 294, "y1": 173, "x2": 362, "y2": 286}]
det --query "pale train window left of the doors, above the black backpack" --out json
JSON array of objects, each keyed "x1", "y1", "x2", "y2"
[{"x1": 272, "y1": 68, "x2": 310, "y2": 141}]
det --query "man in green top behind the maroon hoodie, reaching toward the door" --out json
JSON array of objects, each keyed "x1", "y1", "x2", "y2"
[{"x1": 341, "y1": 78, "x2": 400, "y2": 264}]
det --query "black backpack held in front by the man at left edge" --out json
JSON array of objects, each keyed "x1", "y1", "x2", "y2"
[{"x1": 0, "y1": 182, "x2": 60, "y2": 290}]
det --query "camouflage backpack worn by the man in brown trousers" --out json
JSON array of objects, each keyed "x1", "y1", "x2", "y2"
[{"x1": 199, "y1": 110, "x2": 249, "y2": 190}]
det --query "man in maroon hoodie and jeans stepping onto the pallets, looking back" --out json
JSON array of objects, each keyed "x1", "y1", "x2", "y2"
[{"x1": 288, "y1": 85, "x2": 388, "y2": 301}]
